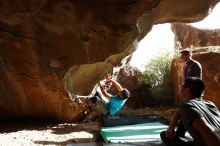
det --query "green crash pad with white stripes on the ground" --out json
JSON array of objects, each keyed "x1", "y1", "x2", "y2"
[{"x1": 100, "y1": 122, "x2": 168, "y2": 143}]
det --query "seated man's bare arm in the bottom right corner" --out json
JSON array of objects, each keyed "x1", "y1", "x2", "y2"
[{"x1": 192, "y1": 117, "x2": 220, "y2": 146}]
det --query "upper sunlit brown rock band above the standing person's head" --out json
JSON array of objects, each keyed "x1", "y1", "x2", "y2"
[{"x1": 172, "y1": 23, "x2": 220, "y2": 48}]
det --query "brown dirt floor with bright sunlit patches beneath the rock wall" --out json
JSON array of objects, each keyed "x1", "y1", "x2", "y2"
[{"x1": 0, "y1": 107, "x2": 174, "y2": 146}]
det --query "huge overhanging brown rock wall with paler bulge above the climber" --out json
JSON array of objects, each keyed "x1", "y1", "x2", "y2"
[{"x1": 0, "y1": 0, "x2": 217, "y2": 121}]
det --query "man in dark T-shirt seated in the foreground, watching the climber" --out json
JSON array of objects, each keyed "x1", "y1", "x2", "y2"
[{"x1": 160, "y1": 77, "x2": 220, "y2": 146}]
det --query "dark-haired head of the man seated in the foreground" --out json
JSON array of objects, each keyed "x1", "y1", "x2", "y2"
[{"x1": 181, "y1": 77, "x2": 205, "y2": 100}]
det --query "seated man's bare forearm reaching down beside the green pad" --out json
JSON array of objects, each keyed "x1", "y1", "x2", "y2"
[{"x1": 166, "y1": 109, "x2": 180, "y2": 139}]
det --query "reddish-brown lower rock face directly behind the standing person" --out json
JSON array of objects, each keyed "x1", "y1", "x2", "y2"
[{"x1": 172, "y1": 51, "x2": 220, "y2": 107}]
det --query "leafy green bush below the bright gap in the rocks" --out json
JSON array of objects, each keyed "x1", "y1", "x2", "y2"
[{"x1": 141, "y1": 51, "x2": 173, "y2": 99}]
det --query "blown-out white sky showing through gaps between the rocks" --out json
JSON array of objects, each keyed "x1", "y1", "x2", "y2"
[{"x1": 130, "y1": 3, "x2": 220, "y2": 71}]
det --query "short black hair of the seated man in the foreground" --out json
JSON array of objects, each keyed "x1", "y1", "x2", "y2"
[{"x1": 184, "y1": 77, "x2": 205, "y2": 98}]
